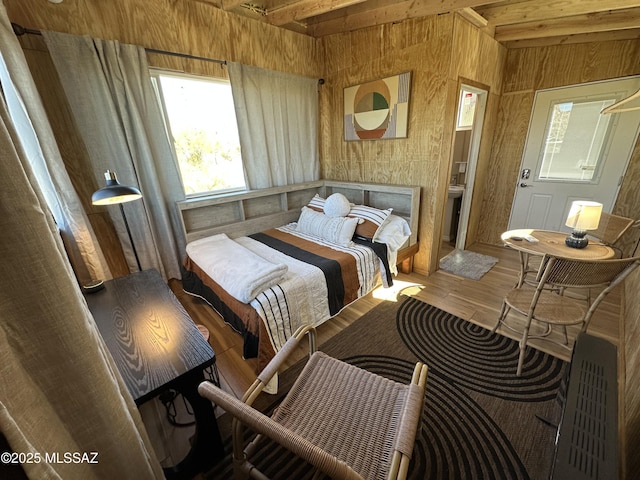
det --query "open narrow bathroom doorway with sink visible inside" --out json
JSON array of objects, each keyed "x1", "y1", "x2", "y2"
[{"x1": 440, "y1": 82, "x2": 488, "y2": 258}]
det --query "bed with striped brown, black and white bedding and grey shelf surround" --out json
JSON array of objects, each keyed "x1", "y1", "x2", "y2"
[{"x1": 178, "y1": 180, "x2": 420, "y2": 370}]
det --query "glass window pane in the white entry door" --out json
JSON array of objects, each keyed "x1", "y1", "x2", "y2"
[{"x1": 538, "y1": 99, "x2": 615, "y2": 182}]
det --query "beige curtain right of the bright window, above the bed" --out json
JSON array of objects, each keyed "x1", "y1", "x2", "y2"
[{"x1": 227, "y1": 62, "x2": 320, "y2": 189}]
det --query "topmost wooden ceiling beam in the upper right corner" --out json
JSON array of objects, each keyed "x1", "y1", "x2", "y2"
[{"x1": 476, "y1": 0, "x2": 640, "y2": 26}]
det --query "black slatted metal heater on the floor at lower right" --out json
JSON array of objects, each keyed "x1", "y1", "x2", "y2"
[{"x1": 553, "y1": 334, "x2": 618, "y2": 480}]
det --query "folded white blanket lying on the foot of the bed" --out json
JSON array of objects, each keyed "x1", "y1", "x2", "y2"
[{"x1": 187, "y1": 233, "x2": 287, "y2": 303}]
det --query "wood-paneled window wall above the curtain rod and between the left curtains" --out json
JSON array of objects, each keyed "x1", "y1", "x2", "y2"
[{"x1": 4, "y1": 0, "x2": 322, "y2": 277}]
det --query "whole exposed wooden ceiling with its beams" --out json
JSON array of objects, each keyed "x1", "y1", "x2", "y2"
[{"x1": 191, "y1": 0, "x2": 640, "y2": 48}]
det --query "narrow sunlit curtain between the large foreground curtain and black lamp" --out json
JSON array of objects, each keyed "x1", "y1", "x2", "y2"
[{"x1": 0, "y1": 4, "x2": 111, "y2": 284}]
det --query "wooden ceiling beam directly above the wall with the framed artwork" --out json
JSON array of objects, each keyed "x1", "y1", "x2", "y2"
[{"x1": 307, "y1": 0, "x2": 500, "y2": 37}]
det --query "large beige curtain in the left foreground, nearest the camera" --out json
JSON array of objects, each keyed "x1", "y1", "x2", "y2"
[{"x1": 0, "y1": 5, "x2": 163, "y2": 479}]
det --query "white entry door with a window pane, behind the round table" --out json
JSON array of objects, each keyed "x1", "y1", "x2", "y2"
[{"x1": 509, "y1": 77, "x2": 640, "y2": 231}]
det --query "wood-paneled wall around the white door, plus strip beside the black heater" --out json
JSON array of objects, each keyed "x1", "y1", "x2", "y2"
[{"x1": 477, "y1": 40, "x2": 640, "y2": 478}]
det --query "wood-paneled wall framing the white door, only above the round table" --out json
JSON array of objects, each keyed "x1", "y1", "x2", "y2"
[{"x1": 478, "y1": 40, "x2": 640, "y2": 248}]
